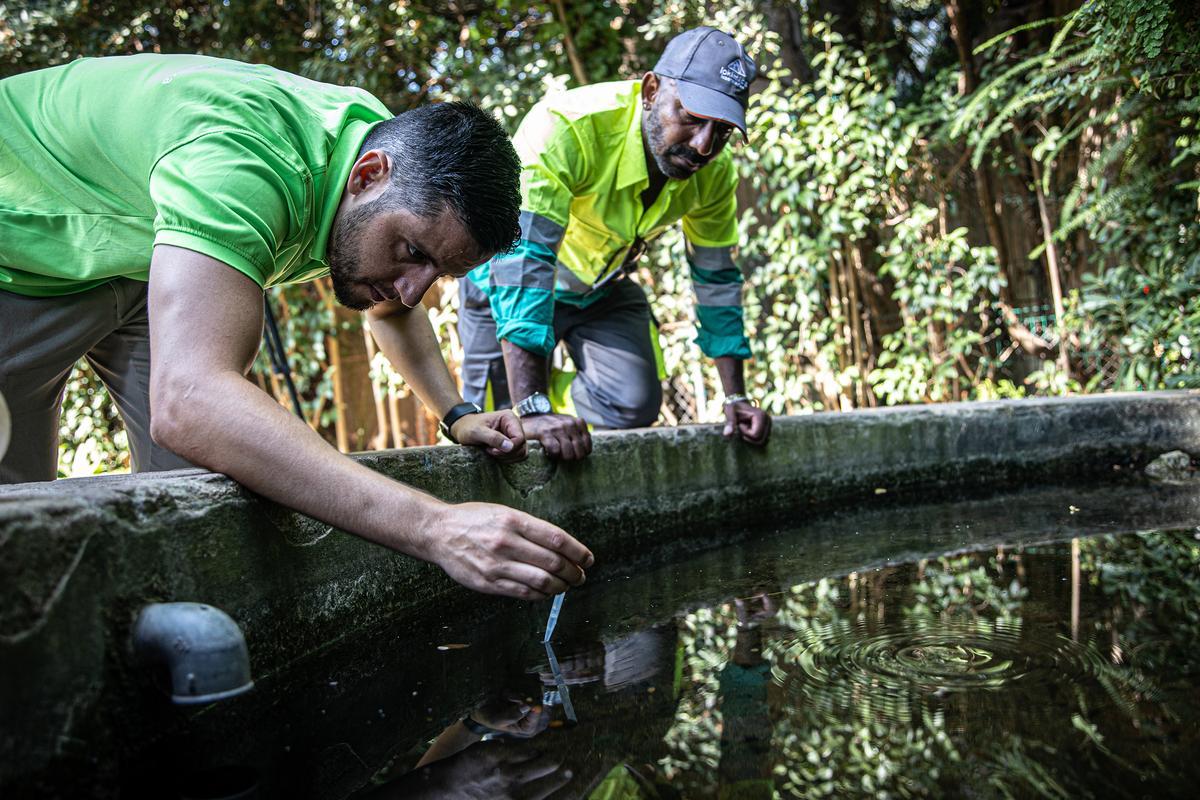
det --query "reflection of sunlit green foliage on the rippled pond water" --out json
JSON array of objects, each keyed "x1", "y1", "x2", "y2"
[{"x1": 659, "y1": 531, "x2": 1200, "y2": 798}]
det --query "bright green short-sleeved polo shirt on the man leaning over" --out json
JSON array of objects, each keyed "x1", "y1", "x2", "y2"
[{"x1": 0, "y1": 54, "x2": 391, "y2": 296}]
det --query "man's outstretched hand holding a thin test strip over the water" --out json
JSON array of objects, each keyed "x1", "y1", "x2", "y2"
[{"x1": 422, "y1": 503, "x2": 595, "y2": 600}]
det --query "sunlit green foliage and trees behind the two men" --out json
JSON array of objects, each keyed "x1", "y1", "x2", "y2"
[{"x1": 0, "y1": 0, "x2": 1200, "y2": 471}]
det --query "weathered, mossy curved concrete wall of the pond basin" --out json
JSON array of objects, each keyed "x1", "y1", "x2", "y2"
[{"x1": 0, "y1": 392, "x2": 1200, "y2": 786}]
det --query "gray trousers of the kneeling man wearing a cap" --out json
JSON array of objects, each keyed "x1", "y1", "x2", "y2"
[{"x1": 458, "y1": 278, "x2": 662, "y2": 428}]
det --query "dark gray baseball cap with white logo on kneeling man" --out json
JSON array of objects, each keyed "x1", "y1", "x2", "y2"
[{"x1": 654, "y1": 26, "x2": 758, "y2": 133}]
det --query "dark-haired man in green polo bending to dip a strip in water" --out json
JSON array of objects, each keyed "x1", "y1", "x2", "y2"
[{"x1": 0, "y1": 55, "x2": 592, "y2": 599}]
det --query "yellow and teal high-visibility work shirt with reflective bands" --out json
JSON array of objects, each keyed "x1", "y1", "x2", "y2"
[{"x1": 470, "y1": 80, "x2": 750, "y2": 359}]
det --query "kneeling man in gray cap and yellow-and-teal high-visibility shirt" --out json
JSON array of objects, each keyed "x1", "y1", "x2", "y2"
[{"x1": 458, "y1": 28, "x2": 770, "y2": 459}]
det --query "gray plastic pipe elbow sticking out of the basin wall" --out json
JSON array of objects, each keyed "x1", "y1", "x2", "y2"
[{"x1": 133, "y1": 602, "x2": 254, "y2": 705}]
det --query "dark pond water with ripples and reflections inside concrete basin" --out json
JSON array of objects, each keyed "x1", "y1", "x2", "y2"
[{"x1": 124, "y1": 487, "x2": 1200, "y2": 799}]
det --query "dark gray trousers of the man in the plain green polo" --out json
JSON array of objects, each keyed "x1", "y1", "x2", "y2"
[{"x1": 0, "y1": 278, "x2": 192, "y2": 483}]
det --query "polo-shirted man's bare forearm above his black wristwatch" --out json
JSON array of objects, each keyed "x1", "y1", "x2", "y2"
[{"x1": 367, "y1": 307, "x2": 462, "y2": 417}]
